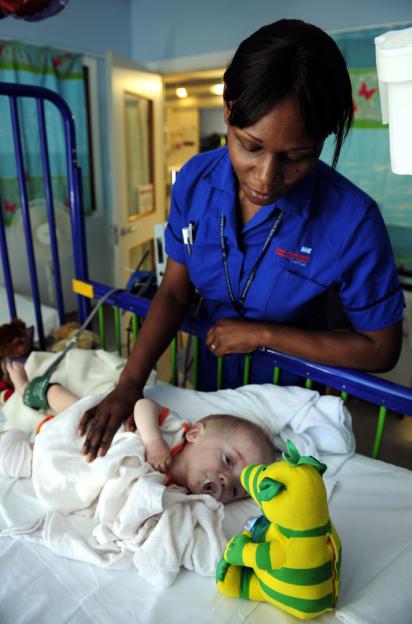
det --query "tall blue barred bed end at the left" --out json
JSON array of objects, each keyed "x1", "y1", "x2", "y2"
[{"x1": 0, "y1": 82, "x2": 89, "y2": 348}]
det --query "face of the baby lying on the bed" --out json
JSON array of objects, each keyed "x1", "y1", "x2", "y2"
[{"x1": 174, "y1": 423, "x2": 267, "y2": 503}]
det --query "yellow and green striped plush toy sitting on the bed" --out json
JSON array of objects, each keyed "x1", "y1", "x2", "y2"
[{"x1": 216, "y1": 440, "x2": 341, "y2": 620}]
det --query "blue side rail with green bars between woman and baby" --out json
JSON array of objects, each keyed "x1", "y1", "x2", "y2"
[{"x1": 75, "y1": 281, "x2": 412, "y2": 457}]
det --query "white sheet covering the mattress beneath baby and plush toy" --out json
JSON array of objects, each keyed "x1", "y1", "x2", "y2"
[{"x1": 0, "y1": 455, "x2": 412, "y2": 624}]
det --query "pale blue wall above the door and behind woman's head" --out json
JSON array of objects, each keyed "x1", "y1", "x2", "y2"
[{"x1": 131, "y1": 0, "x2": 412, "y2": 63}]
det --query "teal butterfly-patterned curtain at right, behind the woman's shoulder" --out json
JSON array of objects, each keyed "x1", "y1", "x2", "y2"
[{"x1": 322, "y1": 23, "x2": 412, "y2": 268}]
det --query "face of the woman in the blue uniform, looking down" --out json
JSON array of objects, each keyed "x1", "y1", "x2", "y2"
[{"x1": 225, "y1": 97, "x2": 321, "y2": 213}]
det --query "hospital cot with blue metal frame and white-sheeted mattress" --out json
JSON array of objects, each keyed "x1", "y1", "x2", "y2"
[{"x1": 0, "y1": 84, "x2": 412, "y2": 624}]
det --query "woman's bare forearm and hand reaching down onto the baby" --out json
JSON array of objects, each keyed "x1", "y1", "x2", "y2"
[{"x1": 79, "y1": 258, "x2": 193, "y2": 461}]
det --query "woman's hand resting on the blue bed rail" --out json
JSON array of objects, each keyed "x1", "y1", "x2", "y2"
[{"x1": 206, "y1": 319, "x2": 263, "y2": 357}]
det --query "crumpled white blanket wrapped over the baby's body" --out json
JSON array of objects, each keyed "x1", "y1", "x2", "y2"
[{"x1": 0, "y1": 396, "x2": 226, "y2": 587}]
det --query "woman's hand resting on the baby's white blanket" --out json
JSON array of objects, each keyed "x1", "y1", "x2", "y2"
[{"x1": 79, "y1": 385, "x2": 143, "y2": 462}]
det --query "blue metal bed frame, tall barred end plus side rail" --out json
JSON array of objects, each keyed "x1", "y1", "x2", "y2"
[{"x1": 0, "y1": 83, "x2": 412, "y2": 457}]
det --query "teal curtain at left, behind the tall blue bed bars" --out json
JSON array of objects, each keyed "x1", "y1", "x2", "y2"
[{"x1": 0, "y1": 41, "x2": 92, "y2": 224}]
